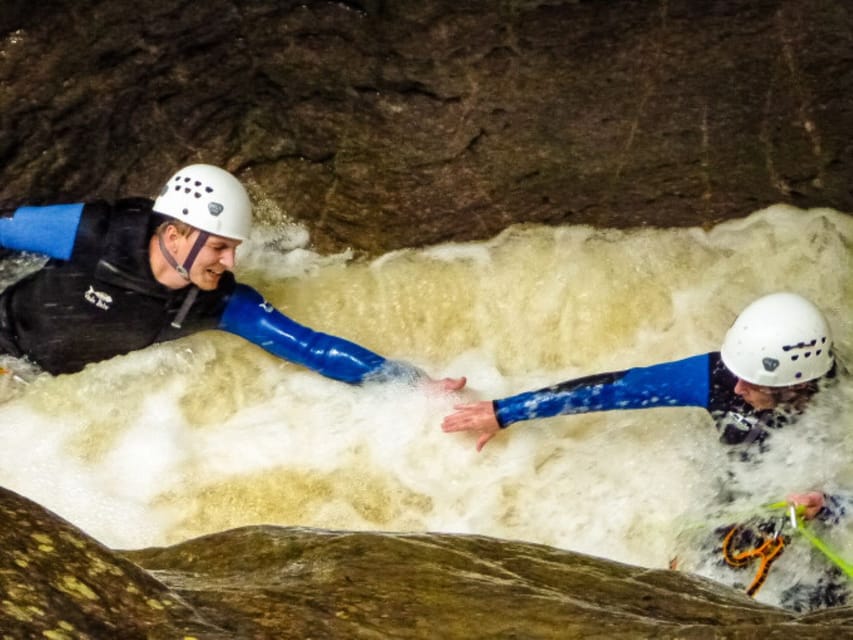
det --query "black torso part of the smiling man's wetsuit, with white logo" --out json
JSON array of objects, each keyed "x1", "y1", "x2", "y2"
[{"x1": 0, "y1": 199, "x2": 235, "y2": 374}]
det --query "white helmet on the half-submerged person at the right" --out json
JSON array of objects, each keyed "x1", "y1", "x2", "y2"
[{"x1": 720, "y1": 292, "x2": 833, "y2": 387}]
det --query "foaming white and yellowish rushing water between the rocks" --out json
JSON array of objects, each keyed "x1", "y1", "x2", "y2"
[{"x1": 0, "y1": 207, "x2": 853, "y2": 602}]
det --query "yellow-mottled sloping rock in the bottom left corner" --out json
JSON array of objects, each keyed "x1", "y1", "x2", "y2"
[{"x1": 0, "y1": 488, "x2": 230, "y2": 640}]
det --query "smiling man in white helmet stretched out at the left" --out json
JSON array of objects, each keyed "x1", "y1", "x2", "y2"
[{"x1": 0, "y1": 164, "x2": 465, "y2": 390}]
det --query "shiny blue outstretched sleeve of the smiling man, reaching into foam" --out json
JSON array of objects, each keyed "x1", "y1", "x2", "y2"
[{"x1": 218, "y1": 284, "x2": 424, "y2": 384}]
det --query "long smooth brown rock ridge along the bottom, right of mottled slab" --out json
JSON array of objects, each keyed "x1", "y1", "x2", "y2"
[{"x1": 129, "y1": 527, "x2": 853, "y2": 640}]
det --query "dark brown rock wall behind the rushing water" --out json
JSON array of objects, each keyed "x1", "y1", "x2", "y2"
[{"x1": 0, "y1": 0, "x2": 853, "y2": 253}]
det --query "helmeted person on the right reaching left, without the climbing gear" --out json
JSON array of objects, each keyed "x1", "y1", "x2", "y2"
[{"x1": 442, "y1": 292, "x2": 835, "y2": 517}]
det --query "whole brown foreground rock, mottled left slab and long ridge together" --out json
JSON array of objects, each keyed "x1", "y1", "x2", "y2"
[{"x1": 0, "y1": 488, "x2": 853, "y2": 640}]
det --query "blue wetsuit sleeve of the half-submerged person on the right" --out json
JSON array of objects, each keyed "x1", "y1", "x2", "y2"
[{"x1": 494, "y1": 354, "x2": 711, "y2": 427}]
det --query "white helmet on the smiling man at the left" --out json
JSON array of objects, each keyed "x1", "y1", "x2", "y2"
[{"x1": 154, "y1": 164, "x2": 252, "y2": 240}]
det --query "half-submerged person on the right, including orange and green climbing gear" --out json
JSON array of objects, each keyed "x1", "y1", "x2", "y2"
[{"x1": 442, "y1": 293, "x2": 851, "y2": 611}]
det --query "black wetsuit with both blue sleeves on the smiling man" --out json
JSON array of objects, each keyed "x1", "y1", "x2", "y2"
[{"x1": 0, "y1": 198, "x2": 425, "y2": 384}]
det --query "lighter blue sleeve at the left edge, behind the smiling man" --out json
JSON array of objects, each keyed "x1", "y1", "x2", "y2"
[{"x1": 0, "y1": 203, "x2": 83, "y2": 260}]
